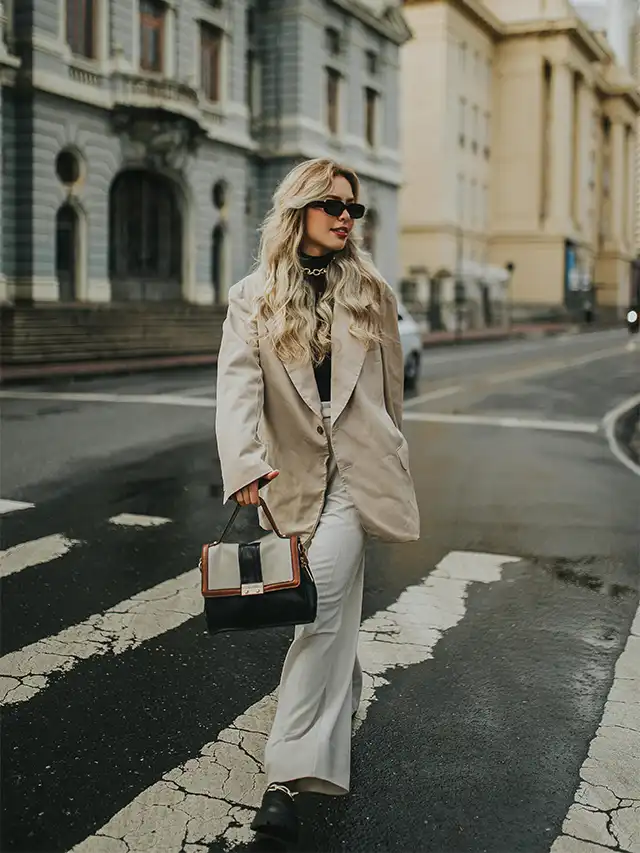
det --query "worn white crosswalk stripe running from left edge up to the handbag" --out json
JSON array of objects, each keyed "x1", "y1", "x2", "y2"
[{"x1": 0, "y1": 569, "x2": 202, "y2": 705}]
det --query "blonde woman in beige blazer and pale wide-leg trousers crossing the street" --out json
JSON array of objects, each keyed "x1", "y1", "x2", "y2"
[{"x1": 216, "y1": 159, "x2": 419, "y2": 841}]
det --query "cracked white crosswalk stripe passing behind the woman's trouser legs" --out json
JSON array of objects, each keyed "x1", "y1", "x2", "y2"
[{"x1": 73, "y1": 552, "x2": 519, "y2": 853}]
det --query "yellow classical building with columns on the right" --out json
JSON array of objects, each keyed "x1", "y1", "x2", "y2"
[{"x1": 401, "y1": 0, "x2": 640, "y2": 327}]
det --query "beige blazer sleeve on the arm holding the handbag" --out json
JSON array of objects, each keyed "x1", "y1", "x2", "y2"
[{"x1": 216, "y1": 282, "x2": 273, "y2": 503}]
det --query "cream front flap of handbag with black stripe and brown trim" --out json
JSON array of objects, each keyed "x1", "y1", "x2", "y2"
[{"x1": 202, "y1": 533, "x2": 300, "y2": 596}]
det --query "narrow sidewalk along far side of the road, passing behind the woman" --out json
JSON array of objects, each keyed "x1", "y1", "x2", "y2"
[{"x1": 0, "y1": 323, "x2": 597, "y2": 385}]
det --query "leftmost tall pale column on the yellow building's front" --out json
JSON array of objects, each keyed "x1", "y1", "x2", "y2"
[{"x1": 549, "y1": 63, "x2": 573, "y2": 234}]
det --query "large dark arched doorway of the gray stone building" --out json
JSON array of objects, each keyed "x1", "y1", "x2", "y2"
[{"x1": 109, "y1": 170, "x2": 182, "y2": 300}]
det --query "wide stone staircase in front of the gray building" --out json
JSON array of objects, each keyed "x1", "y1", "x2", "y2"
[{"x1": 0, "y1": 302, "x2": 226, "y2": 366}]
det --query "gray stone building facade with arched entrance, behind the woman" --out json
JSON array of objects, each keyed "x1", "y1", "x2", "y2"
[{"x1": 0, "y1": 0, "x2": 410, "y2": 304}]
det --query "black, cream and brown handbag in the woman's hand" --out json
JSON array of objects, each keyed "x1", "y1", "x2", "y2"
[{"x1": 199, "y1": 498, "x2": 318, "y2": 634}]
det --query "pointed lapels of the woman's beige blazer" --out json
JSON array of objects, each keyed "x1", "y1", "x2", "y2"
[{"x1": 267, "y1": 305, "x2": 367, "y2": 424}]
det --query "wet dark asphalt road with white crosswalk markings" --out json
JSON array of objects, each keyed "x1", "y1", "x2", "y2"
[{"x1": 0, "y1": 332, "x2": 640, "y2": 853}]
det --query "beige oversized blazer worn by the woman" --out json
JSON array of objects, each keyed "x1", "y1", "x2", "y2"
[{"x1": 216, "y1": 271, "x2": 420, "y2": 542}]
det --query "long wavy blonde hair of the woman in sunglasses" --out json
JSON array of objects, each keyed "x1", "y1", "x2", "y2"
[{"x1": 257, "y1": 158, "x2": 387, "y2": 364}]
